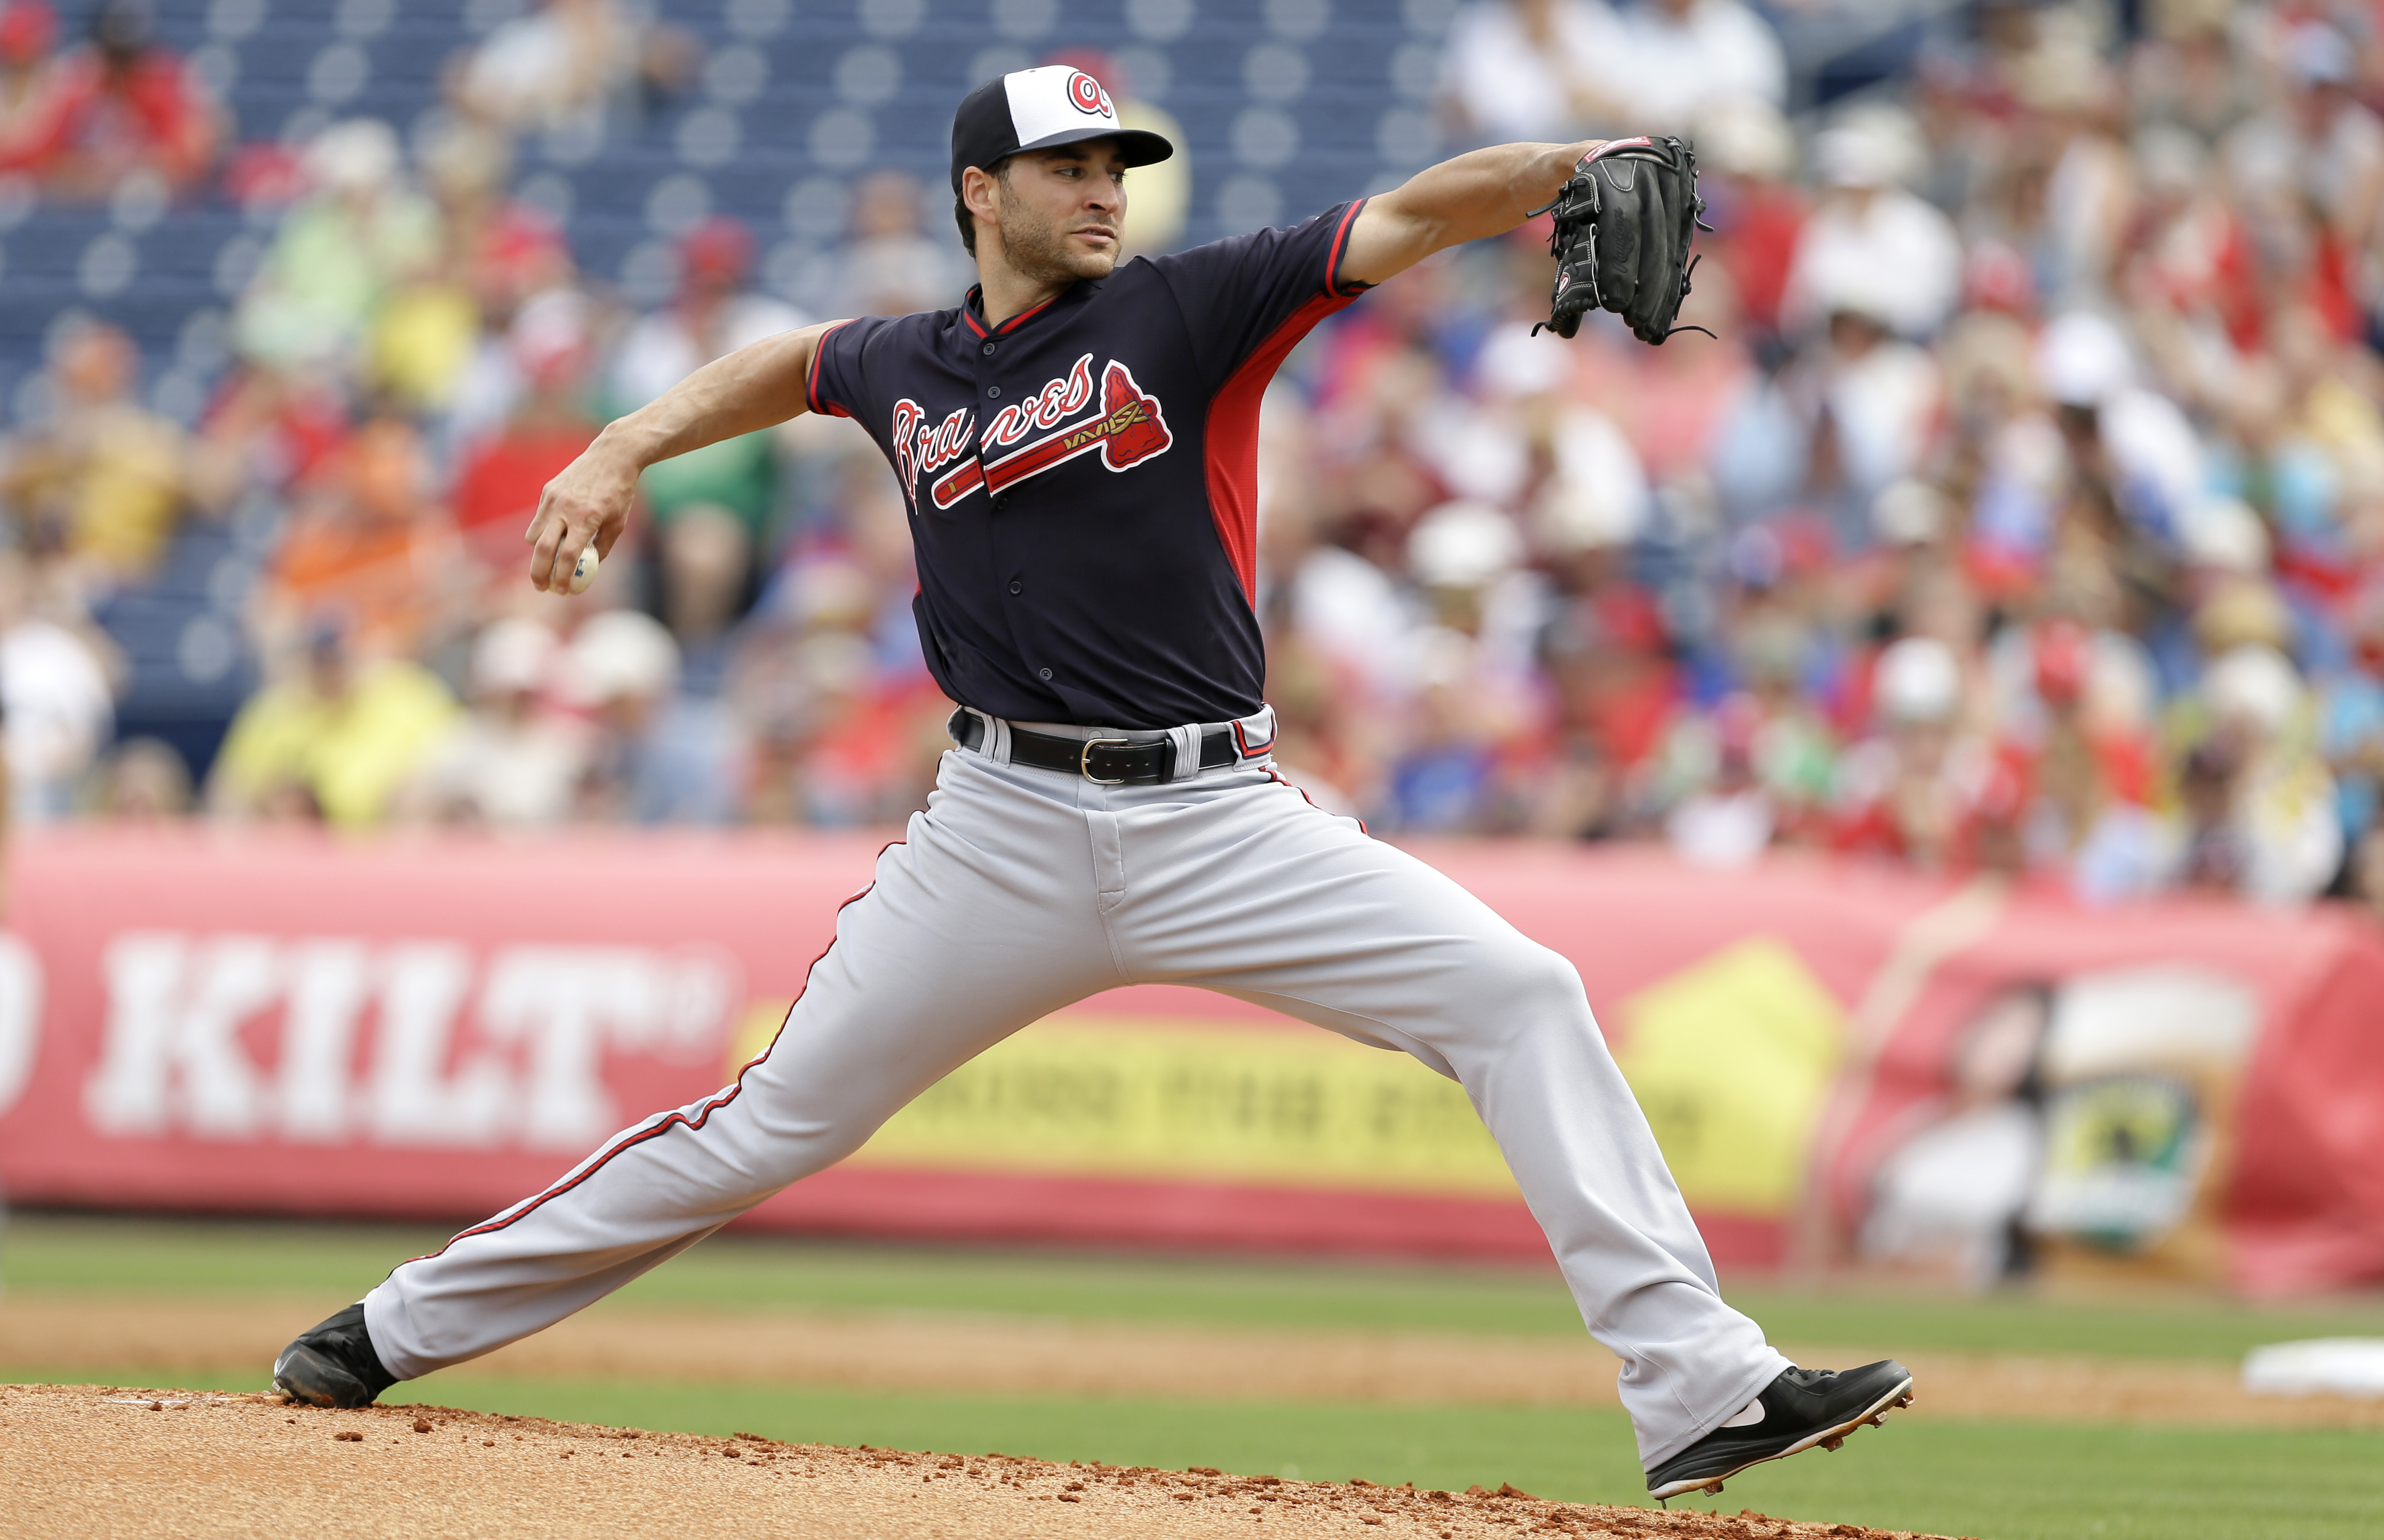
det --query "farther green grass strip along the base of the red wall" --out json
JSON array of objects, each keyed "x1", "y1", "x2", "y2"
[{"x1": 0, "y1": 1216, "x2": 2384, "y2": 1361}]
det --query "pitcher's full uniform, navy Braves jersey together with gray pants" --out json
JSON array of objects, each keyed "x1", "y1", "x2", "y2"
[{"x1": 365, "y1": 205, "x2": 1788, "y2": 1464}]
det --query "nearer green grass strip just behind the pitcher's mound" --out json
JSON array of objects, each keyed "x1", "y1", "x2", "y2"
[{"x1": 0, "y1": 1366, "x2": 2384, "y2": 1540}]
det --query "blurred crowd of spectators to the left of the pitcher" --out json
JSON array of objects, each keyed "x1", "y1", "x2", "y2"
[{"x1": 0, "y1": 0, "x2": 968, "y2": 829}]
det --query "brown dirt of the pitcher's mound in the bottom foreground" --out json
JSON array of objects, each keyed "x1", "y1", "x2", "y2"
[{"x1": 0, "y1": 1385, "x2": 1954, "y2": 1540}]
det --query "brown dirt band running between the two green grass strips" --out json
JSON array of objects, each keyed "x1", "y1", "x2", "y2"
[{"x1": 0, "y1": 1294, "x2": 2384, "y2": 1428}]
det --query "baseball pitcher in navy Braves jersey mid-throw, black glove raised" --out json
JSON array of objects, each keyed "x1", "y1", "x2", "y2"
[{"x1": 274, "y1": 65, "x2": 1912, "y2": 1497}]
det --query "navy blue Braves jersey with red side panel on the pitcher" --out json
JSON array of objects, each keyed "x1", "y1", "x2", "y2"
[{"x1": 806, "y1": 203, "x2": 1361, "y2": 727}]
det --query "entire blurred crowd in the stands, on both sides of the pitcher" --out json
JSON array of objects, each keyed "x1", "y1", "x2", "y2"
[{"x1": 14, "y1": 0, "x2": 2384, "y2": 906}]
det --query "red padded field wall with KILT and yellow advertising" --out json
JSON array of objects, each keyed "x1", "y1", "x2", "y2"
[{"x1": 0, "y1": 829, "x2": 2384, "y2": 1292}]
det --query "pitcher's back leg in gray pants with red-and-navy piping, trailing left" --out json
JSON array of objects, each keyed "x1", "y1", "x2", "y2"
[{"x1": 365, "y1": 756, "x2": 1118, "y2": 1381}]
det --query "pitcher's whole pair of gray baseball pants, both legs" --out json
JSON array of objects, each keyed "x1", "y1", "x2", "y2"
[{"x1": 365, "y1": 713, "x2": 1788, "y2": 1466}]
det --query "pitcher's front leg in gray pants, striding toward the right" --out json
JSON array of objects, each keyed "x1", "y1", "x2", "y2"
[{"x1": 1111, "y1": 787, "x2": 1788, "y2": 1464}]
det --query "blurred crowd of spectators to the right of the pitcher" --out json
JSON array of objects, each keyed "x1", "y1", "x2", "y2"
[{"x1": 1264, "y1": 0, "x2": 2384, "y2": 904}]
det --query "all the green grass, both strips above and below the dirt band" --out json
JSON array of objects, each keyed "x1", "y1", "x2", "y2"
[{"x1": 14, "y1": 1216, "x2": 2384, "y2": 1540}]
